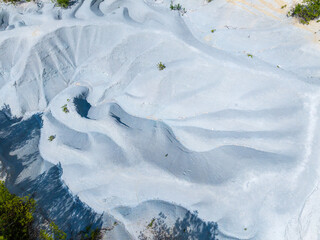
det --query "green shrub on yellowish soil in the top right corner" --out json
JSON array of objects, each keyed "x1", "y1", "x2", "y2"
[{"x1": 288, "y1": 0, "x2": 320, "y2": 24}]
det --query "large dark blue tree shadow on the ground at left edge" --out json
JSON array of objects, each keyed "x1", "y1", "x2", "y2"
[{"x1": 0, "y1": 106, "x2": 102, "y2": 239}]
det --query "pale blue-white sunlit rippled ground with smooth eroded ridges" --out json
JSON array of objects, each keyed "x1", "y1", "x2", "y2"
[{"x1": 0, "y1": 0, "x2": 320, "y2": 240}]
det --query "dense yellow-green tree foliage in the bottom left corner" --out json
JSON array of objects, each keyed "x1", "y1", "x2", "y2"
[{"x1": 0, "y1": 181, "x2": 35, "y2": 240}]
